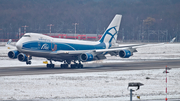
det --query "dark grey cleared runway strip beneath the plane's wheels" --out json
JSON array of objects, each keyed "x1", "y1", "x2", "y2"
[{"x1": 0, "y1": 59, "x2": 180, "y2": 76}]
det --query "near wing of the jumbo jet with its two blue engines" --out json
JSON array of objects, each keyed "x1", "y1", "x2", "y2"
[{"x1": 52, "y1": 43, "x2": 163, "y2": 62}]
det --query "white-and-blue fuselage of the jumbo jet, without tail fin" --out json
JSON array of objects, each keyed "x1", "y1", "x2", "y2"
[{"x1": 16, "y1": 33, "x2": 109, "y2": 58}]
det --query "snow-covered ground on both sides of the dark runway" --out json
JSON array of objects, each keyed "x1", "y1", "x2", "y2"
[{"x1": 0, "y1": 44, "x2": 180, "y2": 101}]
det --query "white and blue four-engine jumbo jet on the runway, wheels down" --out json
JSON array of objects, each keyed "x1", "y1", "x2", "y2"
[{"x1": 8, "y1": 14, "x2": 139, "y2": 68}]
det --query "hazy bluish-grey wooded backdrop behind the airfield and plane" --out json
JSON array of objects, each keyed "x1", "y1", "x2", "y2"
[{"x1": 0, "y1": 0, "x2": 180, "y2": 41}]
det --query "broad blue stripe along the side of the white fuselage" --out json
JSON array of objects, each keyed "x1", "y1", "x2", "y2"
[{"x1": 22, "y1": 41, "x2": 106, "y2": 51}]
